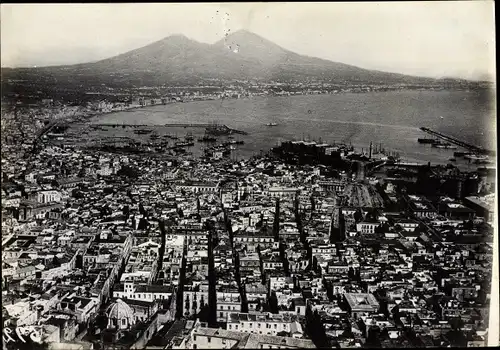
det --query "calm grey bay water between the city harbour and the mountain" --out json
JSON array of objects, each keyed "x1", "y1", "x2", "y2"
[{"x1": 87, "y1": 90, "x2": 496, "y2": 166}]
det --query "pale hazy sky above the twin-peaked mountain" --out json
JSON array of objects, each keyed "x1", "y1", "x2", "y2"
[{"x1": 1, "y1": 0, "x2": 495, "y2": 78}]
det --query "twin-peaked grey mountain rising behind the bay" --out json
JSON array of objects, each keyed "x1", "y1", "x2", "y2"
[{"x1": 2, "y1": 30, "x2": 468, "y2": 95}]
